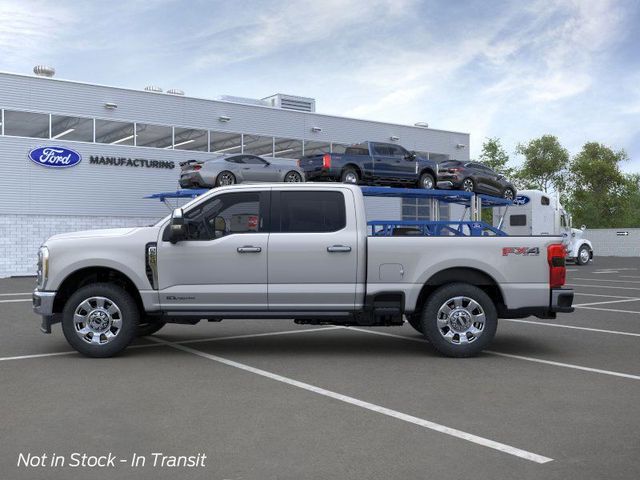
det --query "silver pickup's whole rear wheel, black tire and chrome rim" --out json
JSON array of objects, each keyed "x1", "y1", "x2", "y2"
[{"x1": 422, "y1": 283, "x2": 498, "y2": 357}]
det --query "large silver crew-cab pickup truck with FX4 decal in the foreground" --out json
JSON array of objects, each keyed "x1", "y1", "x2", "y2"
[{"x1": 33, "y1": 184, "x2": 573, "y2": 357}]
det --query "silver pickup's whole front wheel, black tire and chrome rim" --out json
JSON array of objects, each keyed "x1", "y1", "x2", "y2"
[{"x1": 62, "y1": 283, "x2": 140, "y2": 357}]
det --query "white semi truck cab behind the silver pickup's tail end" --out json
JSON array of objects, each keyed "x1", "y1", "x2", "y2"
[{"x1": 493, "y1": 190, "x2": 593, "y2": 265}]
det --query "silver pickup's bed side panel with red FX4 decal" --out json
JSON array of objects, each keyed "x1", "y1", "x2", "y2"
[{"x1": 366, "y1": 236, "x2": 562, "y2": 310}]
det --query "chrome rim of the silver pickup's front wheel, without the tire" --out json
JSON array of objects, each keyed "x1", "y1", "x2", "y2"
[{"x1": 73, "y1": 297, "x2": 122, "y2": 345}]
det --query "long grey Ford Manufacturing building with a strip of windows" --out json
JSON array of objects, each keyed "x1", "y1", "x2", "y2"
[{"x1": 0, "y1": 67, "x2": 469, "y2": 277}]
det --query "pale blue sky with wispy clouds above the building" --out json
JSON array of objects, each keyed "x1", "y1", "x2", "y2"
[{"x1": 0, "y1": 0, "x2": 640, "y2": 172}]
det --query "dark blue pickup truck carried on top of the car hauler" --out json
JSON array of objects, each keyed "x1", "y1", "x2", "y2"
[{"x1": 298, "y1": 142, "x2": 438, "y2": 189}]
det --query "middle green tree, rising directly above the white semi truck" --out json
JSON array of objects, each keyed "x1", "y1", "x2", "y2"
[{"x1": 516, "y1": 135, "x2": 569, "y2": 192}]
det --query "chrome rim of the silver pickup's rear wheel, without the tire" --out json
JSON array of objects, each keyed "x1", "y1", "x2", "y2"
[{"x1": 437, "y1": 297, "x2": 485, "y2": 345}]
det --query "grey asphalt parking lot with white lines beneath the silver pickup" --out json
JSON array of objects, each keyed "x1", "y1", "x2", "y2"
[{"x1": 0, "y1": 258, "x2": 640, "y2": 480}]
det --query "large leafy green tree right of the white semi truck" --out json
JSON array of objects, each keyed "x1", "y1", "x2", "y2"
[{"x1": 569, "y1": 142, "x2": 639, "y2": 228}]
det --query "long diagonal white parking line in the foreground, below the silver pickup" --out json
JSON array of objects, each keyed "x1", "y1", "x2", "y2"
[{"x1": 152, "y1": 338, "x2": 553, "y2": 463}]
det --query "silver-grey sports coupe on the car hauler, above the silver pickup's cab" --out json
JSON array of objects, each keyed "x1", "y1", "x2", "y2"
[{"x1": 180, "y1": 154, "x2": 304, "y2": 188}]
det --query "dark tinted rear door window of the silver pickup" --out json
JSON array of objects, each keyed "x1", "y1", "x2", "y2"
[{"x1": 279, "y1": 192, "x2": 347, "y2": 233}]
